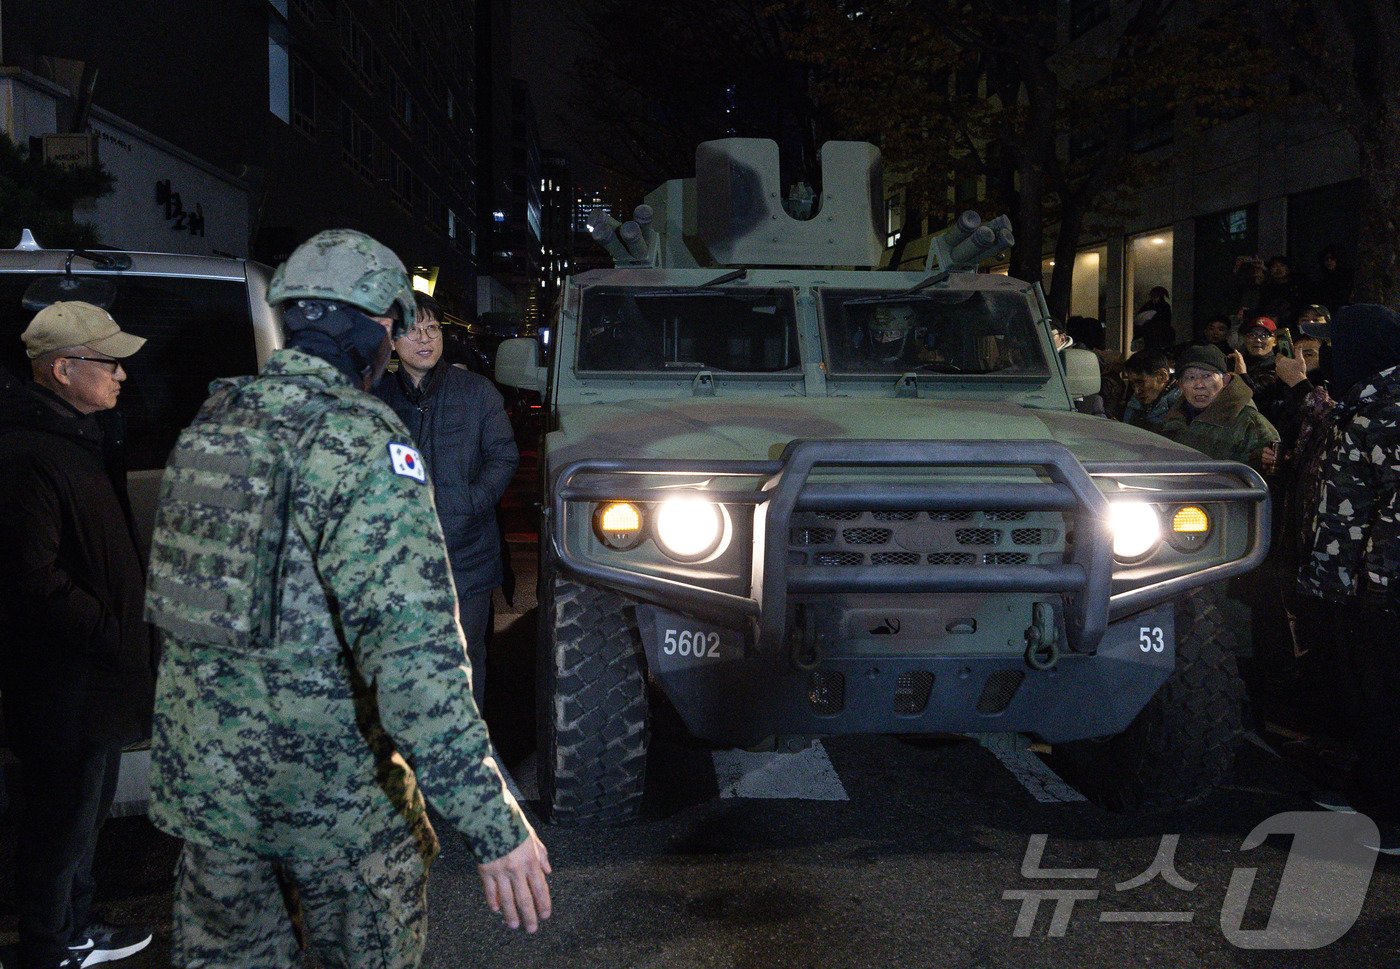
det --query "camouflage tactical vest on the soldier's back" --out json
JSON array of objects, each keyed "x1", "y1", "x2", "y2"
[{"x1": 146, "y1": 378, "x2": 346, "y2": 653}]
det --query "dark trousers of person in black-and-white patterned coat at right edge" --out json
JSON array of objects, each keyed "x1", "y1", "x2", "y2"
[{"x1": 1347, "y1": 606, "x2": 1400, "y2": 822}]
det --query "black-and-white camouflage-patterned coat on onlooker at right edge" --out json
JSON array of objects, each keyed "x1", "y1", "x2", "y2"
[{"x1": 1298, "y1": 367, "x2": 1400, "y2": 609}]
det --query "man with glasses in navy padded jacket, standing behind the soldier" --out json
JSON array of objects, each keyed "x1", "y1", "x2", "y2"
[{"x1": 375, "y1": 293, "x2": 519, "y2": 710}]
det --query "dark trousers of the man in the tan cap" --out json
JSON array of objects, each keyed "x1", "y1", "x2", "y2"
[{"x1": 15, "y1": 746, "x2": 122, "y2": 969}]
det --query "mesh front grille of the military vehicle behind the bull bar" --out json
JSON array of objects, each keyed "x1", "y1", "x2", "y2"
[{"x1": 788, "y1": 511, "x2": 1068, "y2": 569}]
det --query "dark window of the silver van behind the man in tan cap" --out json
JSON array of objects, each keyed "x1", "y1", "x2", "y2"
[{"x1": 0, "y1": 274, "x2": 258, "y2": 470}]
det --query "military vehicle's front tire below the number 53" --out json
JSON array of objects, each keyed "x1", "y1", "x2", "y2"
[{"x1": 1049, "y1": 588, "x2": 1245, "y2": 812}]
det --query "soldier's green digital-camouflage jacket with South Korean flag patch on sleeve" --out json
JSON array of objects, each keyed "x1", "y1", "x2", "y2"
[{"x1": 148, "y1": 350, "x2": 529, "y2": 861}]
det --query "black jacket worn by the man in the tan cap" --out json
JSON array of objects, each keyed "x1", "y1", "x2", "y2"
[{"x1": 0, "y1": 381, "x2": 155, "y2": 756}]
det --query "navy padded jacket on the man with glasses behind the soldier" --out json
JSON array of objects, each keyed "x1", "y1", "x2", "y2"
[{"x1": 374, "y1": 361, "x2": 521, "y2": 595}]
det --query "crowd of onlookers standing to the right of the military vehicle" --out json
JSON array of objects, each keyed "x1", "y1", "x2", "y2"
[{"x1": 1065, "y1": 251, "x2": 1400, "y2": 834}]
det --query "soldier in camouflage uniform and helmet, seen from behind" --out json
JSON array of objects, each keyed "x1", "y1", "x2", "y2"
[{"x1": 147, "y1": 230, "x2": 550, "y2": 969}]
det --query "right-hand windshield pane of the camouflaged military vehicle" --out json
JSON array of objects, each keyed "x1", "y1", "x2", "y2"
[{"x1": 822, "y1": 290, "x2": 1050, "y2": 377}]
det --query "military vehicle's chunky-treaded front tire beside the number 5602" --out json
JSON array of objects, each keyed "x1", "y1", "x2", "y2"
[{"x1": 538, "y1": 571, "x2": 651, "y2": 826}]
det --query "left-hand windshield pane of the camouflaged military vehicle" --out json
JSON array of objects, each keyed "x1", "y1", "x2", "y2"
[{"x1": 578, "y1": 287, "x2": 801, "y2": 374}]
